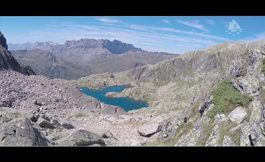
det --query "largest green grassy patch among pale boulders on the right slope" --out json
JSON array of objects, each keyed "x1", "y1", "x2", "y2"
[{"x1": 207, "y1": 79, "x2": 252, "y2": 118}]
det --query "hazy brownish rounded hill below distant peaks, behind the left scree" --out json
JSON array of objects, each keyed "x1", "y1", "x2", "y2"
[{"x1": 11, "y1": 49, "x2": 93, "y2": 79}]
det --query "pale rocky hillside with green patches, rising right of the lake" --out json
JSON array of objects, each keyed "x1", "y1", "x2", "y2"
[{"x1": 74, "y1": 40, "x2": 265, "y2": 146}]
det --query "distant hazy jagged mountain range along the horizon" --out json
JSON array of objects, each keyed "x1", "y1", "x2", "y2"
[{"x1": 8, "y1": 39, "x2": 171, "y2": 62}]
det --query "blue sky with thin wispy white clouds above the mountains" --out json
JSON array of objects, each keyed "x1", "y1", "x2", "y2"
[{"x1": 0, "y1": 16, "x2": 265, "y2": 54}]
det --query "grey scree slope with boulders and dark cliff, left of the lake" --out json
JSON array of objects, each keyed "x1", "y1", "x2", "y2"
[{"x1": 0, "y1": 34, "x2": 136, "y2": 146}]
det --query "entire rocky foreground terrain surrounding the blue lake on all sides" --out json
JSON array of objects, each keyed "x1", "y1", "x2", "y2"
[{"x1": 3, "y1": 28, "x2": 265, "y2": 146}]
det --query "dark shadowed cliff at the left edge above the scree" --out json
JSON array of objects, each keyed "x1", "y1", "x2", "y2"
[{"x1": 0, "y1": 33, "x2": 35, "y2": 75}]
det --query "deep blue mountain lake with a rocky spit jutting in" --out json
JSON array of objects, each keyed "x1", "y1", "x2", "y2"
[{"x1": 80, "y1": 86, "x2": 148, "y2": 112}]
